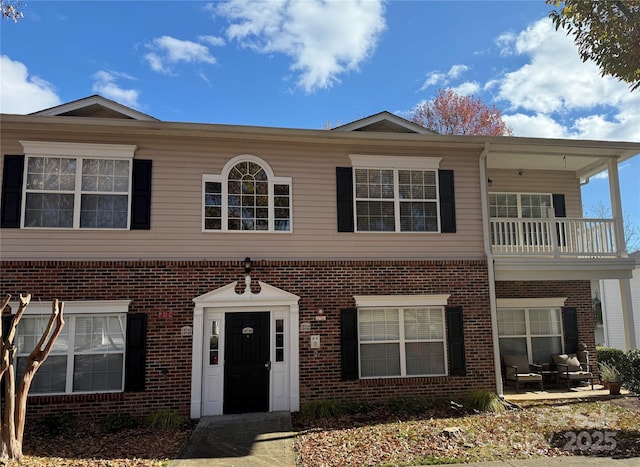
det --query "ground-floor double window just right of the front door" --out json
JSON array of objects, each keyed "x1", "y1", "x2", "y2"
[{"x1": 358, "y1": 298, "x2": 447, "y2": 378}]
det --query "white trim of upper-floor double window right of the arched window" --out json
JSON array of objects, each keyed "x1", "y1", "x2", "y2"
[{"x1": 349, "y1": 154, "x2": 442, "y2": 234}]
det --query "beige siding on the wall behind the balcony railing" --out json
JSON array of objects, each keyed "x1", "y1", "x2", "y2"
[{"x1": 488, "y1": 169, "x2": 583, "y2": 218}]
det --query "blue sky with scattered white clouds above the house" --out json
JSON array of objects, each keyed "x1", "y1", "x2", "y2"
[{"x1": 0, "y1": 0, "x2": 640, "y2": 250}]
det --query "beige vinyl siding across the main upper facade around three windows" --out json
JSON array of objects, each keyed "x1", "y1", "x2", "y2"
[{"x1": 1, "y1": 126, "x2": 484, "y2": 259}]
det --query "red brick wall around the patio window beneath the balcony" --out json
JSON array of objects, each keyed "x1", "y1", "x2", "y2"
[{"x1": 496, "y1": 281, "x2": 597, "y2": 368}]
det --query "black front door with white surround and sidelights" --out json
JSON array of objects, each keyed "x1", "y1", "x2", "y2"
[{"x1": 223, "y1": 312, "x2": 271, "y2": 413}]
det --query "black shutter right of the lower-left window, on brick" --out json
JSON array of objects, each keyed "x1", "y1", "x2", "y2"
[{"x1": 124, "y1": 313, "x2": 147, "y2": 391}]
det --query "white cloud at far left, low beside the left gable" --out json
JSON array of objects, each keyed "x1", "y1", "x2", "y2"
[{"x1": 0, "y1": 55, "x2": 61, "y2": 114}]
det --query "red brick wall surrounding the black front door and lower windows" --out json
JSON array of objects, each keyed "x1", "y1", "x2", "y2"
[{"x1": 0, "y1": 260, "x2": 495, "y2": 416}]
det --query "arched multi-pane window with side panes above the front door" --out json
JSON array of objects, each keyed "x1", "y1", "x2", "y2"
[{"x1": 203, "y1": 156, "x2": 291, "y2": 232}]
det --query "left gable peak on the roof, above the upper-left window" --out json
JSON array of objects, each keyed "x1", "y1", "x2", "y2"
[{"x1": 29, "y1": 94, "x2": 158, "y2": 121}]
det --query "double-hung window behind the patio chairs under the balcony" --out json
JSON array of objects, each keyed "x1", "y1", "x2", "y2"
[{"x1": 498, "y1": 307, "x2": 562, "y2": 363}]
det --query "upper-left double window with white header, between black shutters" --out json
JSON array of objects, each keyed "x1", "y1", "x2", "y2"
[{"x1": 22, "y1": 141, "x2": 135, "y2": 229}]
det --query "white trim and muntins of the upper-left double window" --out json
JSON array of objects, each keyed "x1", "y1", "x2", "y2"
[{"x1": 20, "y1": 140, "x2": 137, "y2": 231}]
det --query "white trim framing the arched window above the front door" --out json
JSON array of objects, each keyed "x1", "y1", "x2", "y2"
[{"x1": 201, "y1": 154, "x2": 293, "y2": 234}]
